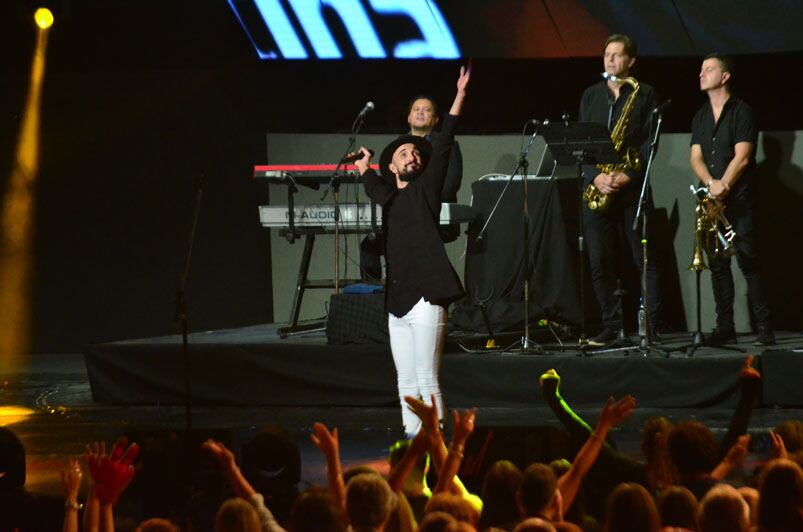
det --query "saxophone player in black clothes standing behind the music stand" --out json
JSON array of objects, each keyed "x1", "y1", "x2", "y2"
[{"x1": 579, "y1": 34, "x2": 662, "y2": 346}]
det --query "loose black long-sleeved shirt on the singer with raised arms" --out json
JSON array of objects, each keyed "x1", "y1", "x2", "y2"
[{"x1": 361, "y1": 115, "x2": 463, "y2": 317}]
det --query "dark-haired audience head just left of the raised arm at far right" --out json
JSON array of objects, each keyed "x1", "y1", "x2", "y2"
[{"x1": 668, "y1": 421, "x2": 717, "y2": 481}]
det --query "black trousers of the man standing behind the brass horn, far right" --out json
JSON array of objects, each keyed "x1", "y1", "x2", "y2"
[{"x1": 708, "y1": 193, "x2": 771, "y2": 330}]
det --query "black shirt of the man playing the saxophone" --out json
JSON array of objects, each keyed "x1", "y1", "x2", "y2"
[{"x1": 578, "y1": 80, "x2": 657, "y2": 204}]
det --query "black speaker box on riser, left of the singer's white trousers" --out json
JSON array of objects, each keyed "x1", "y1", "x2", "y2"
[{"x1": 326, "y1": 294, "x2": 388, "y2": 344}]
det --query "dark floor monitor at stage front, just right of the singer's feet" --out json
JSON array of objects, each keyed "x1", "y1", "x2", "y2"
[{"x1": 460, "y1": 426, "x2": 573, "y2": 494}]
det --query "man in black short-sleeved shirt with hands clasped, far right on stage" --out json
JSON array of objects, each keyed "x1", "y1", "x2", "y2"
[{"x1": 691, "y1": 54, "x2": 775, "y2": 345}]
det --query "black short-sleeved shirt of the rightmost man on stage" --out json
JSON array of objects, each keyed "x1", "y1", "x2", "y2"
[{"x1": 690, "y1": 96, "x2": 758, "y2": 197}]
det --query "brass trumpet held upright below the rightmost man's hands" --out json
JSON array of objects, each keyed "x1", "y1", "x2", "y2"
[{"x1": 689, "y1": 185, "x2": 736, "y2": 270}]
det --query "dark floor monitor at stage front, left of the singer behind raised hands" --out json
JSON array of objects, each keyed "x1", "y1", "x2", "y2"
[{"x1": 120, "y1": 429, "x2": 237, "y2": 525}]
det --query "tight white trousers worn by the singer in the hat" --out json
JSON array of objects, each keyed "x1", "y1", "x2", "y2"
[{"x1": 388, "y1": 298, "x2": 446, "y2": 438}]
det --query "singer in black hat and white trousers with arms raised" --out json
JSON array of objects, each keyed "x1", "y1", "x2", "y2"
[{"x1": 354, "y1": 67, "x2": 470, "y2": 437}]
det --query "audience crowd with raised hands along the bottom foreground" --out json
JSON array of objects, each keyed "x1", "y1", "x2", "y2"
[{"x1": 0, "y1": 357, "x2": 803, "y2": 532}]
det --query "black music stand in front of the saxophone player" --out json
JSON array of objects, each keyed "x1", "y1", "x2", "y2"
[{"x1": 539, "y1": 121, "x2": 637, "y2": 355}]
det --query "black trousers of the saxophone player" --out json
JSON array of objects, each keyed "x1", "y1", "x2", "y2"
[{"x1": 583, "y1": 197, "x2": 663, "y2": 330}]
